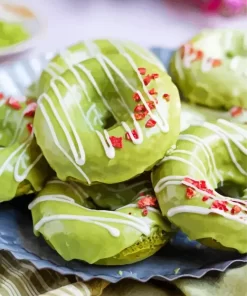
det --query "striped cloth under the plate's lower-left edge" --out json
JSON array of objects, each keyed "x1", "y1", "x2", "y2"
[{"x1": 0, "y1": 251, "x2": 108, "y2": 296}]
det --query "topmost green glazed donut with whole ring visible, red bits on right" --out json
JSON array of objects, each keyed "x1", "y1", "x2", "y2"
[{"x1": 34, "y1": 45, "x2": 180, "y2": 184}]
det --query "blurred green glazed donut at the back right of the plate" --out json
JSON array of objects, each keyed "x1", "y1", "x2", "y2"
[{"x1": 170, "y1": 29, "x2": 247, "y2": 110}]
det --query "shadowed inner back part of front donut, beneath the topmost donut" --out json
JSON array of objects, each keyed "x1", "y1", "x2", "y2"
[{"x1": 81, "y1": 173, "x2": 153, "y2": 210}]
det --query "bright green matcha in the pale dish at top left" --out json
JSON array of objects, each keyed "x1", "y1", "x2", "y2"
[{"x1": 0, "y1": 21, "x2": 30, "y2": 48}]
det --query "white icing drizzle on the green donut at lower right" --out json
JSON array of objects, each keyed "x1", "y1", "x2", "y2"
[{"x1": 154, "y1": 119, "x2": 247, "y2": 224}]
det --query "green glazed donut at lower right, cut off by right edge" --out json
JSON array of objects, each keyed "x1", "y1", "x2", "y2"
[{"x1": 152, "y1": 119, "x2": 247, "y2": 253}]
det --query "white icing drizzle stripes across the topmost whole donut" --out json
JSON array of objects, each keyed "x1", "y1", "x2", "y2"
[{"x1": 39, "y1": 41, "x2": 169, "y2": 166}]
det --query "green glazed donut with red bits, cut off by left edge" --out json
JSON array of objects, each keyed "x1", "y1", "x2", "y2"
[{"x1": 0, "y1": 93, "x2": 51, "y2": 202}]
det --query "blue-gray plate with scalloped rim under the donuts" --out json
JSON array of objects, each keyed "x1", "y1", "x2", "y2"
[{"x1": 0, "y1": 48, "x2": 247, "y2": 283}]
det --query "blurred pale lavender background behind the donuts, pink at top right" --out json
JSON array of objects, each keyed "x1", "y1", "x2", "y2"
[{"x1": 0, "y1": 0, "x2": 247, "y2": 57}]
